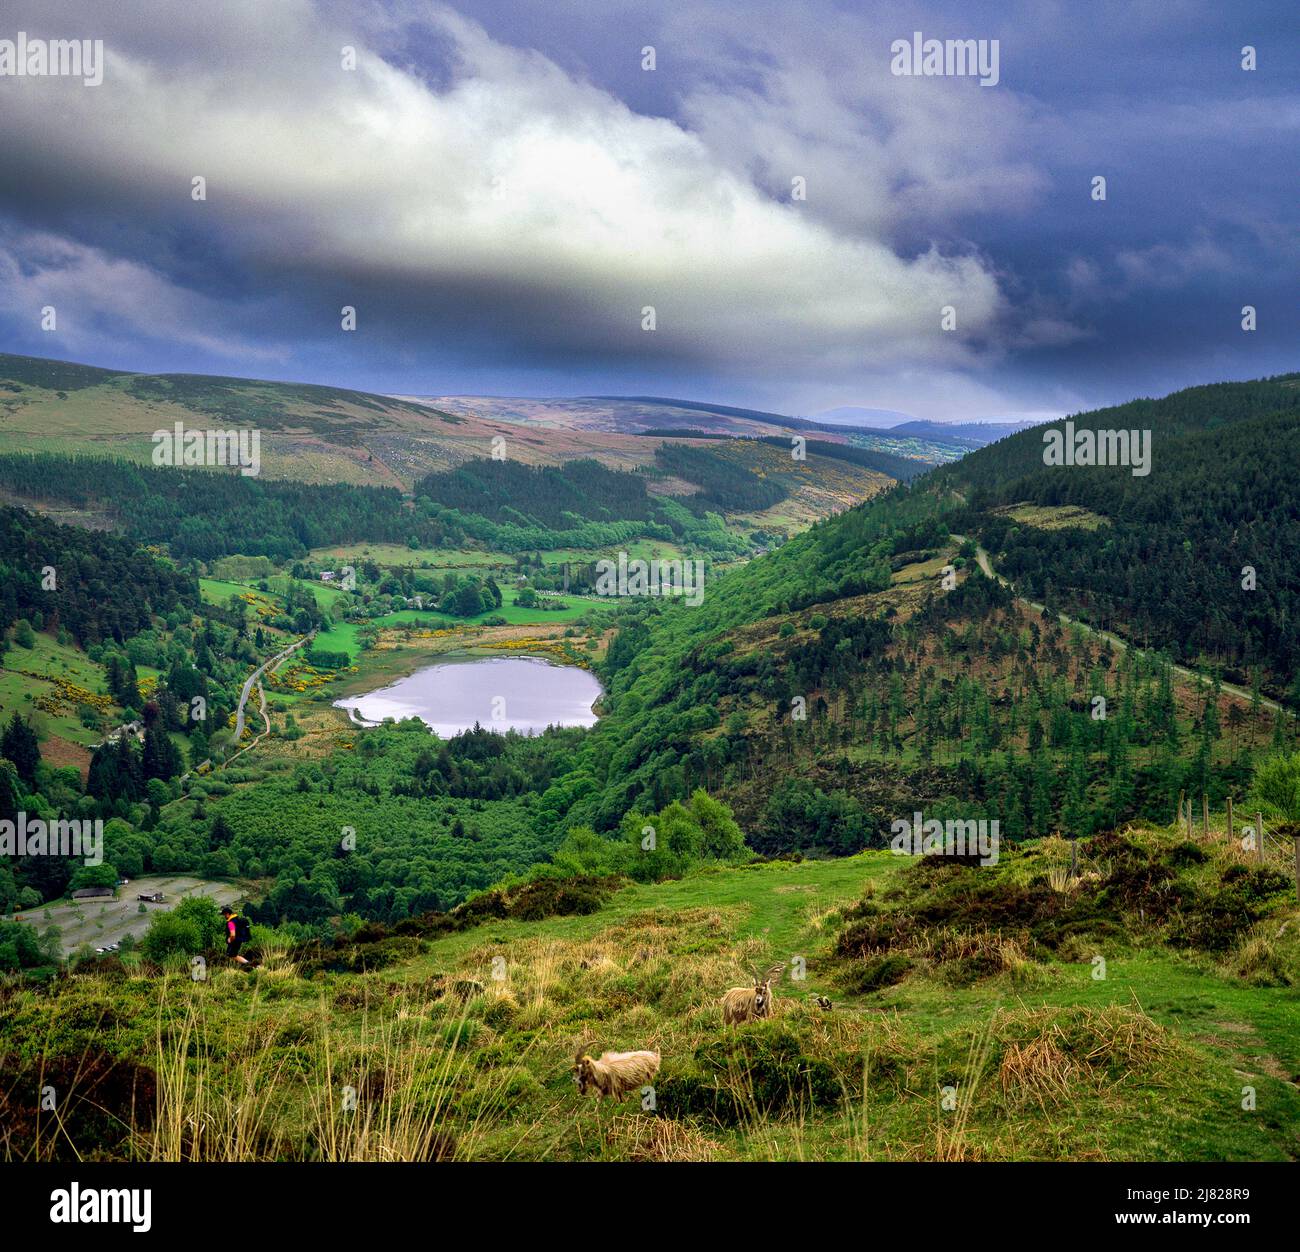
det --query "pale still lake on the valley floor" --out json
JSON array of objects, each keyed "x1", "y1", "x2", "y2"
[{"x1": 334, "y1": 657, "x2": 601, "y2": 738}]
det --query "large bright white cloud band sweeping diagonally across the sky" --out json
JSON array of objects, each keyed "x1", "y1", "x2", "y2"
[{"x1": 0, "y1": 0, "x2": 1003, "y2": 372}]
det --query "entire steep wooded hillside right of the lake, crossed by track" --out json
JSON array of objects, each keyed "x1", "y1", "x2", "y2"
[{"x1": 522, "y1": 369, "x2": 1300, "y2": 852}]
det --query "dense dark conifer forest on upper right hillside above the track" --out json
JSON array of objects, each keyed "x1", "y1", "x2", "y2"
[{"x1": 926, "y1": 374, "x2": 1300, "y2": 707}]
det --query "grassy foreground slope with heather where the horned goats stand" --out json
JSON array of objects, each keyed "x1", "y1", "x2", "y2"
[{"x1": 0, "y1": 828, "x2": 1300, "y2": 1160}]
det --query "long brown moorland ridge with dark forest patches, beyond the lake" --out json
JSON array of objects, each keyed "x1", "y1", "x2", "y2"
[{"x1": 0, "y1": 355, "x2": 904, "y2": 556}]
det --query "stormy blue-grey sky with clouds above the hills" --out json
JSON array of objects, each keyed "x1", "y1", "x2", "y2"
[{"x1": 0, "y1": 0, "x2": 1300, "y2": 419}]
